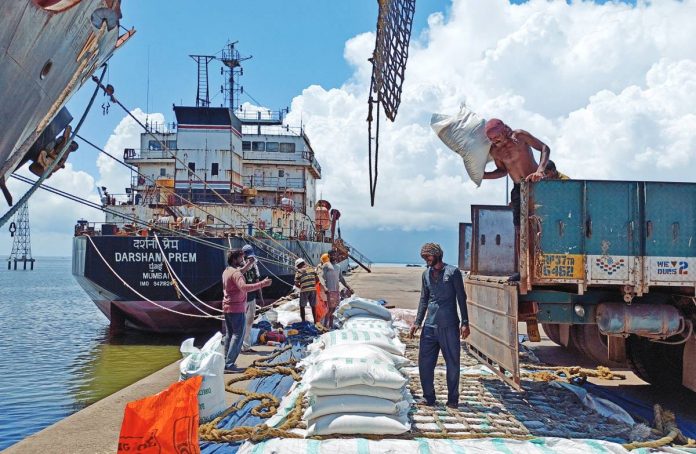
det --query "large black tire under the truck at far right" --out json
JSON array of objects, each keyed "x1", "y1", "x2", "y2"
[{"x1": 626, "y1": 336, "x2": 684, "y2": 387}]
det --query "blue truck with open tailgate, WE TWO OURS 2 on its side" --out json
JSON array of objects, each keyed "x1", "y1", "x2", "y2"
[{"x1": 459, "y1": 180, "x2": 696, "y2": 391}]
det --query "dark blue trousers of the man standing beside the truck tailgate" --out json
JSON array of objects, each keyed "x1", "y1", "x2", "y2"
[{"x1": 418, "y1": 325, "x2": 461, "y2": 405}]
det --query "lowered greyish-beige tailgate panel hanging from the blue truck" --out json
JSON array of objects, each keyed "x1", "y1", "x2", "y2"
[{"x1": 464, "y1": 276, "x2": 522, "y2": 391}]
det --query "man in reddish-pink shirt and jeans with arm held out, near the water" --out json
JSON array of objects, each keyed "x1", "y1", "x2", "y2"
[{"x1": 222, "y1": 249, "x2": 271, "y2": 373}]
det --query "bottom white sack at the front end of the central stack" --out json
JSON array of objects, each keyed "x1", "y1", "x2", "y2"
[{"x1": 307, "y1": 412, "x2": 411, "y2": 437}]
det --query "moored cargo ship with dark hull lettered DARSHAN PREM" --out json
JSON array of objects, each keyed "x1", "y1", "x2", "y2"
[{"x1": 73, "y1": 44, "x2": 370, "y2": 333}]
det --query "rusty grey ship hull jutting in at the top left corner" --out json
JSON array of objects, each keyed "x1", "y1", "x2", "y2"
[{"x1": 0, "y1": 0, "x2": 135, "y2": 205}]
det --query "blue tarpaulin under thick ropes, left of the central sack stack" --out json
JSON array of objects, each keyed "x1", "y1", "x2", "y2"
[{"x1": 200, "y1": 347, "x2": 303, "y2": 454}]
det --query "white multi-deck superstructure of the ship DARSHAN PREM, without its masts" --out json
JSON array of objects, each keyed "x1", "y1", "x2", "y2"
[{"x1": 107, "y1": 106, "x2": 321, "y2": 238}]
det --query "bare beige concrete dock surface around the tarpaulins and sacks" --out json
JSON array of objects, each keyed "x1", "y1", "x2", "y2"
[{"x1": 4, "y1": 267, "x2": 693, "y2": 454}]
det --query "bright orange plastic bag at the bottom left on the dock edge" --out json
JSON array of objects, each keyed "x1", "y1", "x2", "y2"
[{"x1": 118, "y1": 376, "x2": 203, "y2": 454}]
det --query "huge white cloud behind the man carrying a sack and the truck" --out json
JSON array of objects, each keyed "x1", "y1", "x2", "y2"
[{"x1": 288, "y1": 0, "x2": 696, "y2": 230}]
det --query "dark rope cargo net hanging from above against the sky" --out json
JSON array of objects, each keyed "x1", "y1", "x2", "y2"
[{"x1": 367, "y1": 0, "x2": 416, "y2": 206}]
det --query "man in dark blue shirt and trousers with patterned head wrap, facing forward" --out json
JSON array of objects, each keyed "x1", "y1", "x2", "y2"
[{"x1": 410, "y1": 243, "x2": 470, "y2": 408}]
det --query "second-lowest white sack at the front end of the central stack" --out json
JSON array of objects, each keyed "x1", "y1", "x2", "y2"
[{"x1": 302, "y1": 394, "x2": 410, "y2": 425}]
